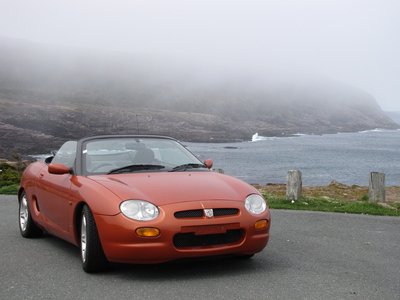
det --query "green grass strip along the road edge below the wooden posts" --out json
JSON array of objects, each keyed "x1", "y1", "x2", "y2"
[{"x1": 263, "y1": 192, "x2": 400, "y2": 216}]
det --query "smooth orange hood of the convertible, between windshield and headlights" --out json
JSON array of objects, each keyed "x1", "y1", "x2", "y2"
[{"x1": 89, "y1": 172, "x2": 258, "y2": 205}]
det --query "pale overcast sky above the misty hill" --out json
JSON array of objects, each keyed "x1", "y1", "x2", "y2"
[{"x1": 0, "y1": 0, "x2": 400, "y2": 111}]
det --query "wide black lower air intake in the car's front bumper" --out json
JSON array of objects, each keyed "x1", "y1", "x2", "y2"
[{"x1": 174, "y1": 229, "x2": 243, "y2": 248}]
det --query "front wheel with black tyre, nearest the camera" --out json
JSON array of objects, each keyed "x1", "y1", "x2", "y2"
[{"x1": 80, "y1": 205, "x2": 107, "y2": 273}]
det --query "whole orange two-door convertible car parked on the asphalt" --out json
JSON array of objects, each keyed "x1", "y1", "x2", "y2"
[{"x1": 18, "y1": 136, "x2": 270, "y2": 272}]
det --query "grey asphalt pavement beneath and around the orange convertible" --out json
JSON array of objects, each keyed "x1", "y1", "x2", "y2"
[{"x1": 0, "y1": 196, "x2": 400, "y2": 299}]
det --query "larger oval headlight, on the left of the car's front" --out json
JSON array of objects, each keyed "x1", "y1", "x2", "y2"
[{"x1": 120, "y1": 200, "x2": 159, "y2": 221}]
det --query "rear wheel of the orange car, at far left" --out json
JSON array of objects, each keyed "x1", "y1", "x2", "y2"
[{"x1": 18, "y1": 192, "x2": 43, "y2": 238}]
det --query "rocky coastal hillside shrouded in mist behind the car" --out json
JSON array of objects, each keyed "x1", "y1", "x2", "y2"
[{"x1": 0, "y1": 38, "x2": 399, "y2": 156}]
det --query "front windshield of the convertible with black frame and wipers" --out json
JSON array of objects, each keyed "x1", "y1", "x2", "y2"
[{"x1": 82, "y1": 137, "x2": 206, "y2": 174}]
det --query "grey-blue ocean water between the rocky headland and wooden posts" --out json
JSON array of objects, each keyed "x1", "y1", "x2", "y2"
[{"x1": 184, "y1": 130, "x2": 400, "y2": 186}]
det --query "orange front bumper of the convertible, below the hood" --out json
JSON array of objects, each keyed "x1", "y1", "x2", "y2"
[{"x1": 94, "y1": 201, "x2": 270, "y2": 264}]
